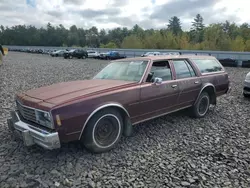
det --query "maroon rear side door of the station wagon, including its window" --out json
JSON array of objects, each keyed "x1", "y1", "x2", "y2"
[{"x1": 171, "y1": 59, "x2": 202, "y2": 107}]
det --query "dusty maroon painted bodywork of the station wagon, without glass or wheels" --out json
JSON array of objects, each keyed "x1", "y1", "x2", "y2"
[{"x1": 12, "y1": 56, "x2": 229, "y2": 145}]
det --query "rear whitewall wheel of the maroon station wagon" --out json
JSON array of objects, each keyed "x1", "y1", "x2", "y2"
[{"x1": 192, "y1": 91, "x2": 210, "y2": 118}]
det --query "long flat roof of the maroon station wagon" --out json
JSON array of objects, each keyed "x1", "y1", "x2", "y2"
[{"x1": 115, "y1": 55, "x2": 215, "y2": 61}]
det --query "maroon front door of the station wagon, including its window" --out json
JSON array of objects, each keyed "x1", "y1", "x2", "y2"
[{"x1": 132, "y1": 60, "x2": 179, "y2": 123}]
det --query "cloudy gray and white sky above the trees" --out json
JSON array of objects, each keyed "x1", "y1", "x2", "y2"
[{"x1": 0, "y1": 0, "x2": 250, "y2": 30}]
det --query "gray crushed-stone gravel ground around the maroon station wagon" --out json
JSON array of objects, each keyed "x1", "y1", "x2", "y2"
[{"x1": 0, "y1": 52, "x2": 250, "y2": 188}]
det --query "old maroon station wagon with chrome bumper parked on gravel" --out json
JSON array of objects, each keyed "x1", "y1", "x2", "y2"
[{"x1": 7, "y1": 55, "x2": 230, "y2": 153}]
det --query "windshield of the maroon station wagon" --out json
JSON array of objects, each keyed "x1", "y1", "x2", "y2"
[{"x1": 93, "y1": 61, "x2": 148, "y2": 82}]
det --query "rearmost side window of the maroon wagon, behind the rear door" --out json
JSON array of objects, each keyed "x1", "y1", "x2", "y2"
[{"x1": 192, "y1": 59, "x2": 223, "y2": 74}]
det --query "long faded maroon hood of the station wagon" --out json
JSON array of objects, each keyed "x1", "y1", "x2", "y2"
[{"x1": 17, "y1": 79, "x2": 134, "y2": 108}]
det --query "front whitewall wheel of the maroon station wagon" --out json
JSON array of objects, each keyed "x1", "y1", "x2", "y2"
[{"x1": 81, "y1": 108, "x2": 123, "y2": 153}]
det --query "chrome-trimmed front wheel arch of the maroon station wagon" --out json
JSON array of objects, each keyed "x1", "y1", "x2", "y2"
[{"x1": 78, "y1": 102, "x2": 130, "y2": 140}]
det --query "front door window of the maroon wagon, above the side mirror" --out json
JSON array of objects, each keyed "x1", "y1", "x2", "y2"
[{"x1": 146, "y1": 61, "x2": 172, "y2": 82}]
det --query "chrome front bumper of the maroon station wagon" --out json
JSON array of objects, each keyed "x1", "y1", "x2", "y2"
[{"x1": 7, "y1": 111, "x2": 61, "y2": 150}]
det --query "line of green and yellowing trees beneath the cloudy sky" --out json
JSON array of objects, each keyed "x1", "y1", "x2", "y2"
[{"x1": 0, "y1": 14, "x2": 250, "y2": 51}]
